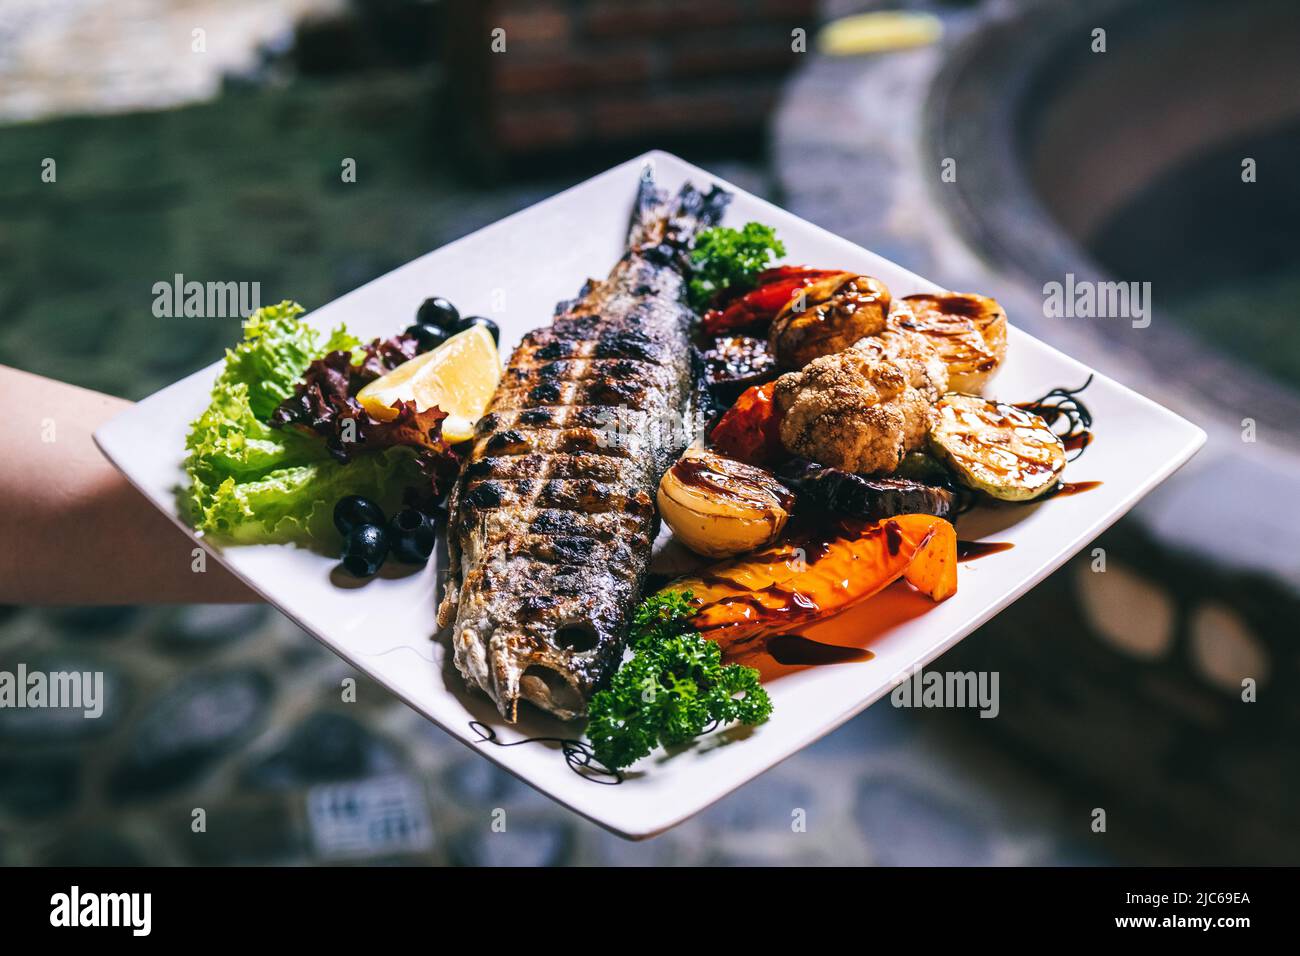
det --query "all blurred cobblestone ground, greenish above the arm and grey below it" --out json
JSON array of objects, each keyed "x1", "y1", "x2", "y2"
[{"x1": 0, "y1": 63, "x2": 1222, "y2": 864}]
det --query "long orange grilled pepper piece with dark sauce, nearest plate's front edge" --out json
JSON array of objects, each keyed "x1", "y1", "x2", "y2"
[{"x1": 660, "y1": 515, "x2": 957, "y2": 653}]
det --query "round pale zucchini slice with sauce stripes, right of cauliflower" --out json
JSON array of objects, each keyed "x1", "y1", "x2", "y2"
[{"x1": 930, "y1": 393, "x2": 1065, "y2": 501}]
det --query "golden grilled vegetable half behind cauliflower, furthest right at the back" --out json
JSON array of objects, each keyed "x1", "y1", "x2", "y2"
[{"x1": 889, "y1": 293, "x2": 1006, "y2": 393}]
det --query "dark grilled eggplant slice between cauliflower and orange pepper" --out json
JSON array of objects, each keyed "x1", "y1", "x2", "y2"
[{"x1": 777, "y1": 458, "x2": 956, "y2": 522}]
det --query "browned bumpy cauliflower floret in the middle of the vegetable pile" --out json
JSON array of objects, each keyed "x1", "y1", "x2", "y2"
[{"x1": 775, "y1": 349, "x2": 932, "y2": 473}]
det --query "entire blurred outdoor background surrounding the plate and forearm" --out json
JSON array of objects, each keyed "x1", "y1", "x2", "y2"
[{"x1": 0, "y1": 0, "x2": 1300, "y2": 865}]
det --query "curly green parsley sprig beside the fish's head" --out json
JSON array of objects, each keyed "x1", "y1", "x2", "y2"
[{"x1": 586, "y1": 591, "x2": 772, "y2": 770}]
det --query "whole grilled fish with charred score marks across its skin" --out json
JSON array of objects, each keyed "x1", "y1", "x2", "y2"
[{"x1": 438, "y1": 170, "x2": 731, "y2": 721}]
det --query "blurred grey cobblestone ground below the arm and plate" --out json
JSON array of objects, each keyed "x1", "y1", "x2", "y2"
[{"x1": 0, "y1": 606, "x2": 1144, "y2": 865}]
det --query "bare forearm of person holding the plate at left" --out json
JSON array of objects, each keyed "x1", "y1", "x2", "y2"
[{"x1": 0, "y1": 365, "x2": 259, "y2": 605}]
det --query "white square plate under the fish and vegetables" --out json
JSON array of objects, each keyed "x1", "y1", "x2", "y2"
[{"x1": 95, "y1": 152, "x2": 1205, "y2": 839}]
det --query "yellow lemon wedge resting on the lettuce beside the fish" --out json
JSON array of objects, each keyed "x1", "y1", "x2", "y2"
[{"x1": 356, "y1": 325, "x2": 501, "y2": 445}]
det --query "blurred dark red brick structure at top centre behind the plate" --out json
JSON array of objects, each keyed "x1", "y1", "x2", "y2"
[{"x1": 445, "y1": 0, "x2": 818, "y2": 159}]
